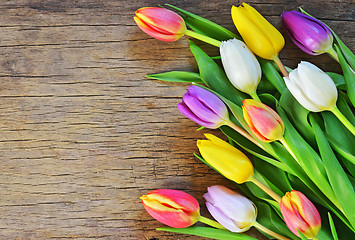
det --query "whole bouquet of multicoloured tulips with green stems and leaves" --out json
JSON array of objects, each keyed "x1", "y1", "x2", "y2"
[{"x1": 134, "y1": 3, "x2": 355, "y2": 240}]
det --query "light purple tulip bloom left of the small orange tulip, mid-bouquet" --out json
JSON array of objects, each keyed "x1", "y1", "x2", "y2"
[{"x1": 177, "y1": 85, "x2": 230, "y2": 129}]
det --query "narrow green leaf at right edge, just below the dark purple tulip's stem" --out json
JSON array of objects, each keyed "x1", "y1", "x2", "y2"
[{"x1": 334, "y1": 45, "x2": 355, "y2": 106}]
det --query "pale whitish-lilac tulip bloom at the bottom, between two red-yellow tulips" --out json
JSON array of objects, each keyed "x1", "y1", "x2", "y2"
[{"x1": 203, "y1": 185, "x2": 257, "y2": 233}]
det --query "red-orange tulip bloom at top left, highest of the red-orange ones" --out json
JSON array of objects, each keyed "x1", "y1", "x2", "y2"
[{"x1": 133, "y1": 7, "x2": 186, "y2": 42}]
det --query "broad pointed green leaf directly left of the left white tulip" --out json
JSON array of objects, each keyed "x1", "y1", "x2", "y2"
[{"x1": 190, "y1": 41, "x2": 247, "y2": 105}]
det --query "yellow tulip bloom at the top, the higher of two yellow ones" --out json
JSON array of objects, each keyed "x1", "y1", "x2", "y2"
[{"x1": 232, "y1": 3, "x2": 285, "y2": 60}]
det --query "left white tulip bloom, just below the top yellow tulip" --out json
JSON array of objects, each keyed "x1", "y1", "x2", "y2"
[{"x1": 219, "y1": 39, "x2": 261, "y2": 94}]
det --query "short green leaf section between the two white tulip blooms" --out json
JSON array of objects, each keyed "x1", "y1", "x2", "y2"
[{"x1": 258, "y1": 57, "x2": 286, "y2": 93}]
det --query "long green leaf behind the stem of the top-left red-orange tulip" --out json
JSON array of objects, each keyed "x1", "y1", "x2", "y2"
[{"x1": 165, "y1": 4, "x2": 241, "y2": 41}]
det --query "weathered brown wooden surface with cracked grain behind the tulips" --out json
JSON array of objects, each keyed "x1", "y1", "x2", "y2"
[{"x1": 0, "y1": 0, "x2": 355, "y2": 240}]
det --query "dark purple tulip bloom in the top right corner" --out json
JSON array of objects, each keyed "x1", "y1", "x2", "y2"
[{"x1": 281, "y1": 11, "x2": 333, "y2": 55}]
